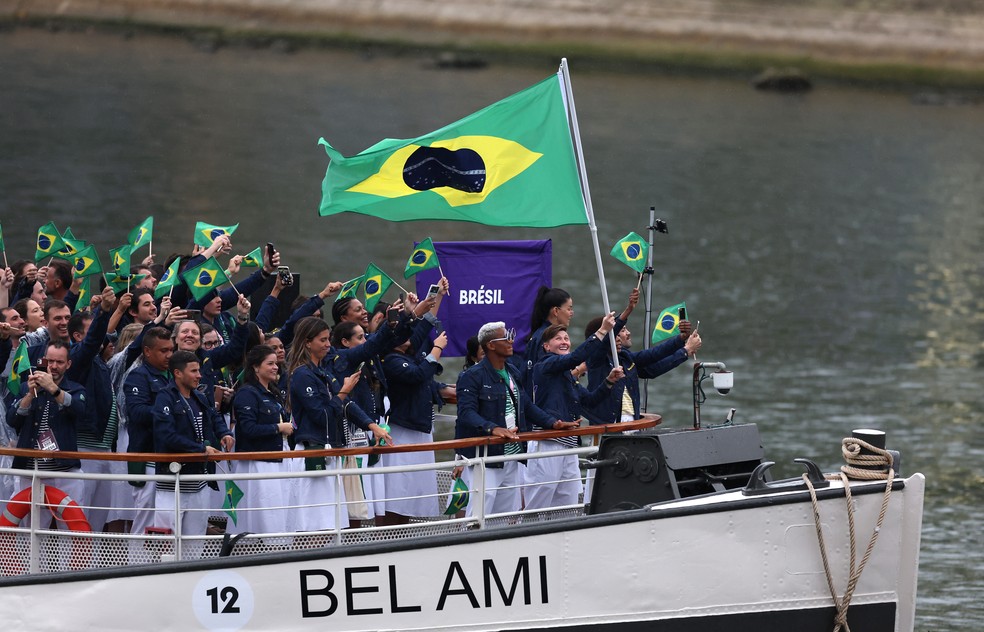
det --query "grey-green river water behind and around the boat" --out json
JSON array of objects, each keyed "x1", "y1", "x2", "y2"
[{"x1": 0, "y1": 31, "x2": 984, "y2": 631}]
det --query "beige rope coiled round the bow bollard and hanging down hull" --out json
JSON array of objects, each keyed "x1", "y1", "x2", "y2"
[{"x1": 803, "y1": 437, "x2": 895, "y2": 632}]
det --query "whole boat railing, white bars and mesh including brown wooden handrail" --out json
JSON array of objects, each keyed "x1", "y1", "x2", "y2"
[{"x1": 0, "y1": 417, "x2": 659, "y2": 576}]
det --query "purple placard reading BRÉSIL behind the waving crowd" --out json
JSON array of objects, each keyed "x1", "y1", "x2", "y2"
[{"x1": 414, "y1": 239, "x2": 553, "y2": 357}]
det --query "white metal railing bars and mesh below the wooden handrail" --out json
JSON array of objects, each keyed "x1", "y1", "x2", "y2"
[{"x1": 0, "y1": 446, "x2": 597, "y2": 575}]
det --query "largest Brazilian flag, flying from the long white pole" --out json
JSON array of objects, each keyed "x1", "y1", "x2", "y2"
[{"x1": 319, "y1": 73, "x2": 588, "y2": 227}]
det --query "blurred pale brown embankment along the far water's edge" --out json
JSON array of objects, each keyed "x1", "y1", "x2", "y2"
[{"x1": 9, "y1": 0, "x2": 984, "y2": 77}]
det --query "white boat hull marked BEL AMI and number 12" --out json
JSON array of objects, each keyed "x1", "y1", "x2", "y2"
[{"x1": 0, "y1": 474, "x2": 924, "y2": 632}]
